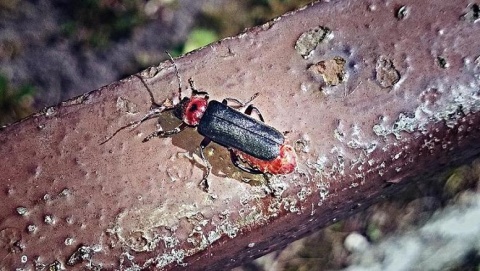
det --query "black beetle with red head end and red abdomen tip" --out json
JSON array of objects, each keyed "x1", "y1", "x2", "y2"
[{"x1": 102, "y1": 56, "x2": 296, "y2": 191}]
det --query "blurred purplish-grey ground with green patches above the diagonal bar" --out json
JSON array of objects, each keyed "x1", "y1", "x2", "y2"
[{"x1": 0, "y1": 0, "x2": 308, "y2": 126}]
